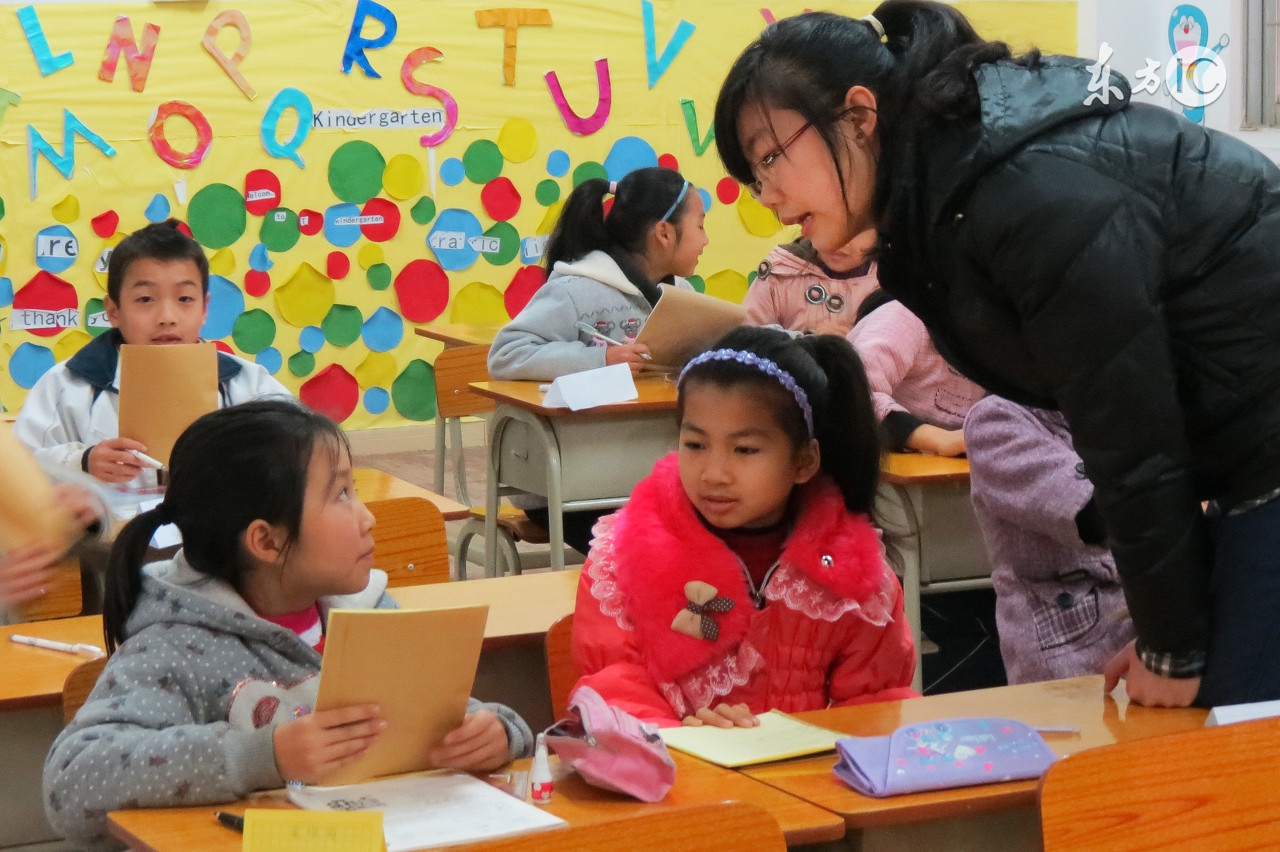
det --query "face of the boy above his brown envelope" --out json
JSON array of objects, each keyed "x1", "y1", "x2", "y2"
[{"x1": 105, "y1": 257, "x2": 209, "y2": 345}]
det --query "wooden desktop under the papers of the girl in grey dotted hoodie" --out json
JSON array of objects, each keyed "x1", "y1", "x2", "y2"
[{"x1": 108, "y1": 752, "x2": 845, "y2": 852}]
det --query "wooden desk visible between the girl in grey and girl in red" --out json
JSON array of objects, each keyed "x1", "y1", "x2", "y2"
[{"x1": 390, "y1": 569, "x2": 580, "y2": 730}]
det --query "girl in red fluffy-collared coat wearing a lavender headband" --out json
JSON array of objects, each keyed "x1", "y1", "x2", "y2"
[{"x1": 573, "y1": 327, "x2": 915, "y2": 727}]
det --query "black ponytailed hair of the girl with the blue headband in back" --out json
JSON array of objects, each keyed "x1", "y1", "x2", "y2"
[{"x1": 543, "y1": 166, "x2": 696, "y2": 304}]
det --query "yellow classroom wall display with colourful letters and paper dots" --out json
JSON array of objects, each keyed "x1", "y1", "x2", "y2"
[{"x1": 0, "y1": 0, "x2": 1076, "y2": 429}]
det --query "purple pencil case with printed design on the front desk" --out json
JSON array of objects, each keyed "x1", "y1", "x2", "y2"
[{"x1": 835, "y1": 718, "x2": 1055, "y2": 798}]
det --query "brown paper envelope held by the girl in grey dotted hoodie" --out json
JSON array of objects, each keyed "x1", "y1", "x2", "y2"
[{"x1": 316, "y1": 606, "x2": 489, "y2": 785}]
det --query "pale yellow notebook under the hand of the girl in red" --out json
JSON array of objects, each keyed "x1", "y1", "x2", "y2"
[{"x1": 659, "y1": 710, "x2": 845, "y2": 768}]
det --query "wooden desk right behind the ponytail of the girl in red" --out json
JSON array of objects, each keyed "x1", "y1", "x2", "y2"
[{"x1": 876, "y1": 453, "x2": 991, "y2": 692}]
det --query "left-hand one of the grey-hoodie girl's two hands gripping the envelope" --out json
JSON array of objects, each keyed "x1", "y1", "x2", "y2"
[{"x1": 271, "y1": 704, "x2": 387, "y2": 784}]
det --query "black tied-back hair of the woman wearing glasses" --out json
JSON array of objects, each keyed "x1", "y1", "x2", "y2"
[{"x1": 716, "y1": 0, "x2": 1039, "y2": 218}]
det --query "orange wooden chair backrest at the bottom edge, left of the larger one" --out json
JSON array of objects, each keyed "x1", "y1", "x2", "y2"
[{"x1": 457, "y1": 802, "x2": 787, "y2": 852}]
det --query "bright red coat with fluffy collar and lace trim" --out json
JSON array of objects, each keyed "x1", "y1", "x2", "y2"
[{"x1": 573, "y1": 453, "x2": 915, "y2": 724}]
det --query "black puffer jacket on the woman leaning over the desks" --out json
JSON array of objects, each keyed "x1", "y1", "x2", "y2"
[{"x1": 879, "y1": 58, "x2": 1280, "y2": 652}]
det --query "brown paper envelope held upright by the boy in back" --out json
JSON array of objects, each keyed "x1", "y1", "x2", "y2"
[{"x1": 120, "y1": 343, "x2": 218, "y2": 464}]
